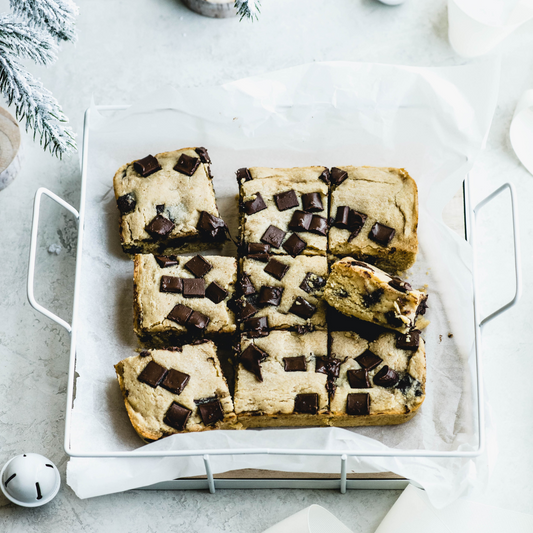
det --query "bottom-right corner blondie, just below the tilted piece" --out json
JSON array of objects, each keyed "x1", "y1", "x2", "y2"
[{"x1": 330, "y1": 330, "x2": 426, "y2": 427}]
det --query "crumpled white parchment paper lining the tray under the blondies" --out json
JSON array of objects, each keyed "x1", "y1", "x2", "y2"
[{"x1": 68, "y1": 62, "x2": 499, "y2": 505}]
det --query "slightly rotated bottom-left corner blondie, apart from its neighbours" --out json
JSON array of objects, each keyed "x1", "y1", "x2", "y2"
[{"x1": 115, "y1": 341, "x2": 237, "y2": 441}]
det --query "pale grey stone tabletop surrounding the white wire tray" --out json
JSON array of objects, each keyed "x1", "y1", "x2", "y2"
[{"x1": 0, "y1": 0, "x2": 533, "y2": 533}]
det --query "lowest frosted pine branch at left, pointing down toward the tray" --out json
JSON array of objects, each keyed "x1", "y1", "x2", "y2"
[{"x1": 0, "y1": 48, "x2": 76, "y2": 157}]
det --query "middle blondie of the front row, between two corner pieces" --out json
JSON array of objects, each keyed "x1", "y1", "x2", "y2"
[{"x1": 234, "y1": 331, "x2": 329, "y2": 428}]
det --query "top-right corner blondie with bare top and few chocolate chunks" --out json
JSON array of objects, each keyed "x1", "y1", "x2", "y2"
[{"x1": 328, "y1": 166, "x2": 418, "y2": 272}]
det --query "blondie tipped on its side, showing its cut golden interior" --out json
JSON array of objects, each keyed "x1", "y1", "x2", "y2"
[{"x1": 324, "y1": 257, "x2": 428, "y2": 333}]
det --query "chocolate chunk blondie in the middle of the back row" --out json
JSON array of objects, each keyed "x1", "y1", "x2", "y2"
[{"x1": 237, "y1": 167, "x2": 328, "y2": 257}]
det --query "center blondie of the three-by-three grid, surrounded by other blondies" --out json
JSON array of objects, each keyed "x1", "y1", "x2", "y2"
[{"x1": 235, "y1": 255, "x2": 328, "y2": 332}]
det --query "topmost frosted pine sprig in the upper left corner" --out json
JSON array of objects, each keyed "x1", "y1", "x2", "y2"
[{"x1": 9, "y1": 0, "x2": 78, "y2": 41}]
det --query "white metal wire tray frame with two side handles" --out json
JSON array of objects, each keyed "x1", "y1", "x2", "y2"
[{"x1": 28, "y1": 106, "x2": 522, "y2": 493}]
